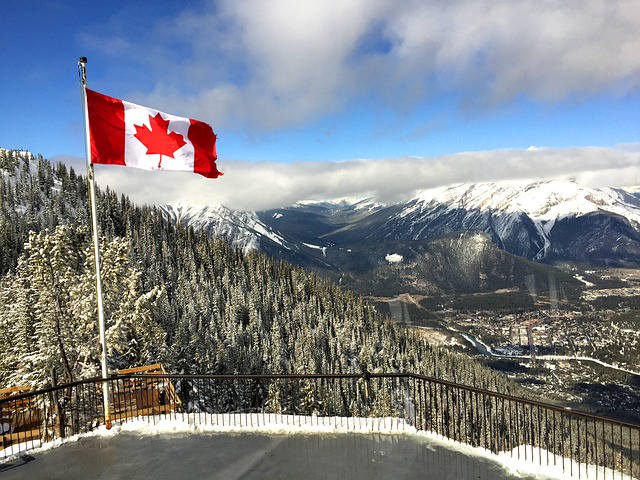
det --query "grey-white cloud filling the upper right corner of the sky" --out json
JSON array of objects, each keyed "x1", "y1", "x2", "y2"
[{"x1": 380, "y1": 0, "x2": 640, "y2": 102}]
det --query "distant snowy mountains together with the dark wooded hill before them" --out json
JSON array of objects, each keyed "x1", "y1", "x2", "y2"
[{"x1": 165, "y1": 181, "x2": 640, "y2": 292}]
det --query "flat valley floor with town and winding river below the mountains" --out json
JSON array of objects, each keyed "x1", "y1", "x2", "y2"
[{"x1": 370, "y1": 269, "x2": 640, "y2": 422}]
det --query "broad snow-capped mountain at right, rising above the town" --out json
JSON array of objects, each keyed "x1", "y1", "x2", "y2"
[{"x1": 338, "y1": 181, "x2": 640, "y2": 264}]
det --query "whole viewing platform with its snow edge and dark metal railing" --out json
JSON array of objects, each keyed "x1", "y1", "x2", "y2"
[{"x1": 0, "y1": 367, "x2": 640, "y2": 480}]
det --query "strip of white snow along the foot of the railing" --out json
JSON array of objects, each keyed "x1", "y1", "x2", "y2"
[{"x1": 3, "y1": 413, "x2": 632, "y2": 480}]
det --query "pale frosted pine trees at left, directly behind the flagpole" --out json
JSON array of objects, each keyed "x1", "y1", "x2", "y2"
[{"x1": 0, "y1": 226, "x2": 166, "y2": 387}]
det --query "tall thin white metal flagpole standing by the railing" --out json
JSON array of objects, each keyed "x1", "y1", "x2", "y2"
[{"x1": 78, "y1": 57, "x2": 111, "y2": 430}]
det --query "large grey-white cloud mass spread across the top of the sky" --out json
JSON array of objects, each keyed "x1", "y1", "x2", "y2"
[{"x1": 82, "y1": 0, "x2": 640, "y2": 131}]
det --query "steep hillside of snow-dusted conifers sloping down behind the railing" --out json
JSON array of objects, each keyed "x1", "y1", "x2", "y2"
[{"x1": 0, "y1": 150, "x2": 517, "y2": 393}]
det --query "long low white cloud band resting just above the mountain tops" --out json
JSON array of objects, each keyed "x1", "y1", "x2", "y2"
[{"x1": 52, "y1": 144, "x2": 640, "y2": 210}]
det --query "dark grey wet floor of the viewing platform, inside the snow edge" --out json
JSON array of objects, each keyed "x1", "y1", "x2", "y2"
[{"x1": 0, "y1": 431, "x2": 561, "y2": 480}]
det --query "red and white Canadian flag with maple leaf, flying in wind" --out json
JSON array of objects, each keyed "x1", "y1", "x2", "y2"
[{"x1": 87, "y1": 88, "x2": 222, "y2": 178}]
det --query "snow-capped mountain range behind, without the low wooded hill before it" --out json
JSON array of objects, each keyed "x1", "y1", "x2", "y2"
[{"x1": 165, "y1": 180, "x2": 640, "y2": 271}]
